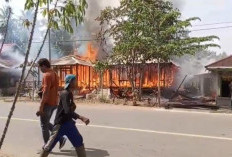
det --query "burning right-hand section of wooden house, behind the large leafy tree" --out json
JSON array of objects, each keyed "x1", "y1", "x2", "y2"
[{"x1": 107, "y1": 62, "x2": 178, "y2": 88}]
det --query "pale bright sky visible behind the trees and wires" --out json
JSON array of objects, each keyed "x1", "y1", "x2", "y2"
[{"x1": 0, "y1": 0, "x2": 232, "y2": 55}]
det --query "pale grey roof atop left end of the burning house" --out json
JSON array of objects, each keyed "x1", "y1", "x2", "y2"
[{"x1": 51, "y1": 55, "x2": 93, "y2": 66}]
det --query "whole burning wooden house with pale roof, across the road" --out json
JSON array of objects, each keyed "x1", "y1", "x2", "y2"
[{"x1": 52, "y1": 55, "x2": 178, "y2": 92}]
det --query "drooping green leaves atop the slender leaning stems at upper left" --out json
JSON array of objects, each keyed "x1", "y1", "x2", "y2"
[{"x1": 25, "y1": 0, "x2": 88, "y2": 33}]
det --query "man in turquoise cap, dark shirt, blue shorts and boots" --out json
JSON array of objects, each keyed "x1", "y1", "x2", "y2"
[{"x1": 40, "y1": 75, "x2": 89, "y2": 157}]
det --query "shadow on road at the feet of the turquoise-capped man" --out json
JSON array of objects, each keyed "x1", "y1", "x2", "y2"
[{"x1": 51, "y1": 148, "x2": 110, "y2": 157}]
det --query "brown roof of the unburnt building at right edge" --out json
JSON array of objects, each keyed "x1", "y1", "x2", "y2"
[{"x1": 205, "y1": 55, "x2": 232, "y2": 71}]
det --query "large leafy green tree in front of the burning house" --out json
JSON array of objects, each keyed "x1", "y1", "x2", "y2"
[{"x1": 97, "y1": 0, "x2": 218, "y2": 105}]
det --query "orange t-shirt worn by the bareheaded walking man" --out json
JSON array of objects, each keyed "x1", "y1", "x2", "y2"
[{"x1": 42, "y1": 70, "x2": 59, "y2": 106}]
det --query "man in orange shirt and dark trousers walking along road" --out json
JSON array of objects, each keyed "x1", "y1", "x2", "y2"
[{"x1": 36, "y1": 58, "x2": 66, "y2": 149}]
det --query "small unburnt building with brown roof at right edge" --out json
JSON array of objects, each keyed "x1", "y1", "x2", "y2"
[{"x1": 205, "y1": 56, "x2": 232, "y2": 107}]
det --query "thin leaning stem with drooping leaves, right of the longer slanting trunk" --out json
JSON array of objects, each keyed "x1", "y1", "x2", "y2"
[{"x1": 24, "y1": 0, "x2": 88, "y2": 82}]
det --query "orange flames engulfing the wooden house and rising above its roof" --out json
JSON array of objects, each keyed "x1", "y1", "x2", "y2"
[{"x1": 54, "y1": 42, "x2": 177, "y2": 93}]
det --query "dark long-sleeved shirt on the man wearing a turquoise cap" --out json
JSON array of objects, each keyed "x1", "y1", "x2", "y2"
[{"x1": 55, "y1": 90, "x2": 80, "y2": 124}]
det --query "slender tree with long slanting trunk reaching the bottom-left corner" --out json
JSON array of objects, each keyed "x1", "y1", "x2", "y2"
[{"x1": 0, "y1": 0, "x2": 87, "y2": 149}]
